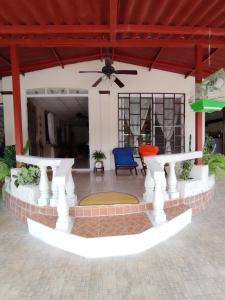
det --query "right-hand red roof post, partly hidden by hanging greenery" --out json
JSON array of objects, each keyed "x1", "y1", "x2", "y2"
[{"x1": 195, "y1": 46, "x2": 203, "y2": 165}]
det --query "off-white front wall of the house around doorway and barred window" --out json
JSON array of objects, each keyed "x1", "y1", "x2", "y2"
[{"x1": 2, "y1": 60, "x2": 195, "y2": 169}]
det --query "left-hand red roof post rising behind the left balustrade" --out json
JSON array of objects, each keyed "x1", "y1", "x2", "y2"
[{"x1": 10, "y1": 45, "x2": 23, "y2": 154}]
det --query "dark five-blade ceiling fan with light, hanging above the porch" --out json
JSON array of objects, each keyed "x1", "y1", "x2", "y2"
[{"x1": 79, "y1": 57, "x2": 137, "y2": 88}]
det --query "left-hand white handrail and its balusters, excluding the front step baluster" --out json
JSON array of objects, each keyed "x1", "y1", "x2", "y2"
[{"x1": 16, "y1": 155, "x2": 77, "y2": 207}]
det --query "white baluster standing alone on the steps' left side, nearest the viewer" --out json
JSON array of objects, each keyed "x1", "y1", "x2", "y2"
[{"x1": 56, "y1": 182, "x2": 73, "y2": 233}]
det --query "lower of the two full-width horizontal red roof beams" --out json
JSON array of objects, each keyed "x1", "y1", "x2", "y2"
[{"x1": 0, "y1": 38, "x2": 225, "y2": 48}]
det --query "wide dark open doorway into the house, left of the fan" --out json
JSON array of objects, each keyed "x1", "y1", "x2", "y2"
[{"x1": 27, "y1": 96, "x2": 90, "y2": 169}]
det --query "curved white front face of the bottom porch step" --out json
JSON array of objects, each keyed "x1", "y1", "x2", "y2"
[{"x1": 27, "y1": 209, "x2": 192, "y2": 258}]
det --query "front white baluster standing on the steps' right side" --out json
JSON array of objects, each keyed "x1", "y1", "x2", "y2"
[{"x1": 151, "y1": 172, "x2": 166, "y2": 226}]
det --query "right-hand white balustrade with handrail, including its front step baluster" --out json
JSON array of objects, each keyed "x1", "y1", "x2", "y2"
[{"x1": 143, "y1": 151, "x2": 202, "y2": 225}]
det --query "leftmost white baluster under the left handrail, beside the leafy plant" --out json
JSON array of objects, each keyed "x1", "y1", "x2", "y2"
[{"x1": 38, "y1": 166, "x2": 49, "y2": 206}]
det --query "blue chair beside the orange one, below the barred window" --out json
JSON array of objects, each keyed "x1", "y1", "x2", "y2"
[{"x1": 112, "y1": 147, "x2": 138, "y2": 175}]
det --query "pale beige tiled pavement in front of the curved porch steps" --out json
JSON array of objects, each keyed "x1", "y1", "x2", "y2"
[{"x1": 0, "y1": 180, "x2": 225, "y2": 300}]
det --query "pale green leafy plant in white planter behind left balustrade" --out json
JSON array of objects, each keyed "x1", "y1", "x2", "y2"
[{"x1": 15, "y1": 165, "x2": 40, "y2": 187}]
